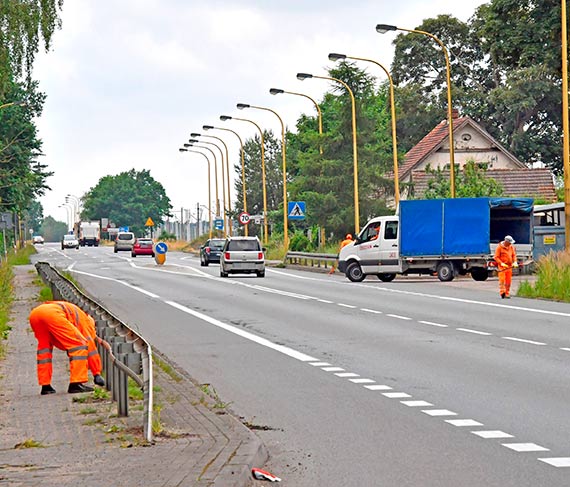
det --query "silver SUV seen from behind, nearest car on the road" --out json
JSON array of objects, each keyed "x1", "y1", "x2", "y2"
[{"x1": 220, "y1": 237, "x2": 265, "y2": 277}]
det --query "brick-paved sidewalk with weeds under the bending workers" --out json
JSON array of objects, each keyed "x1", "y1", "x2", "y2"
[{"x1": 0, "y1": 265, "x2": 267, "y2": 487}]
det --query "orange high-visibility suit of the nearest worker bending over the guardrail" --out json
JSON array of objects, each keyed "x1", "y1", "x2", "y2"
[{"x1": 30, "y1": 302, "x2": 89, "y2": 386}]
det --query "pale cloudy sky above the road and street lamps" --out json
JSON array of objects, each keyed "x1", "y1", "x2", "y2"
[{"x1": 34, "y1": 0, "x2": 485, "y2": 225}]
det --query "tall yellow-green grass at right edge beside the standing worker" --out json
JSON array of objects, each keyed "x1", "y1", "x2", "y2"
[{"x1": 517, "y1": 252, "x2": 570, "y2": 303}]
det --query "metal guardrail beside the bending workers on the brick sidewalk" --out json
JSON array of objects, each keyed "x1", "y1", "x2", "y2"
[{"x1": 36, "y1": 262, "x2": 153, "y2": 441}]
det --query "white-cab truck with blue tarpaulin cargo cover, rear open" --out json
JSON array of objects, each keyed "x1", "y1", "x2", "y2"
[{"x1": 338, "y1": 198, "x2": 533, "y2": 282}]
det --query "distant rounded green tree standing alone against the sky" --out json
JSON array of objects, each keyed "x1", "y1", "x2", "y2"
[{"x1": 81, "y1": 169, "x2": 172, "y2": 235}]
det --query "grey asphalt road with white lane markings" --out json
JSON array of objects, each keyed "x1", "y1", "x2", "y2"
[{"x1": 32, "y1": 244, "x2": 570, "y2": 487}]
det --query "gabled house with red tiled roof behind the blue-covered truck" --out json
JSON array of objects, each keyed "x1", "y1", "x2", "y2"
[{"x1": 398, "y1": 110, "x2": 556, "y2": 201}]
